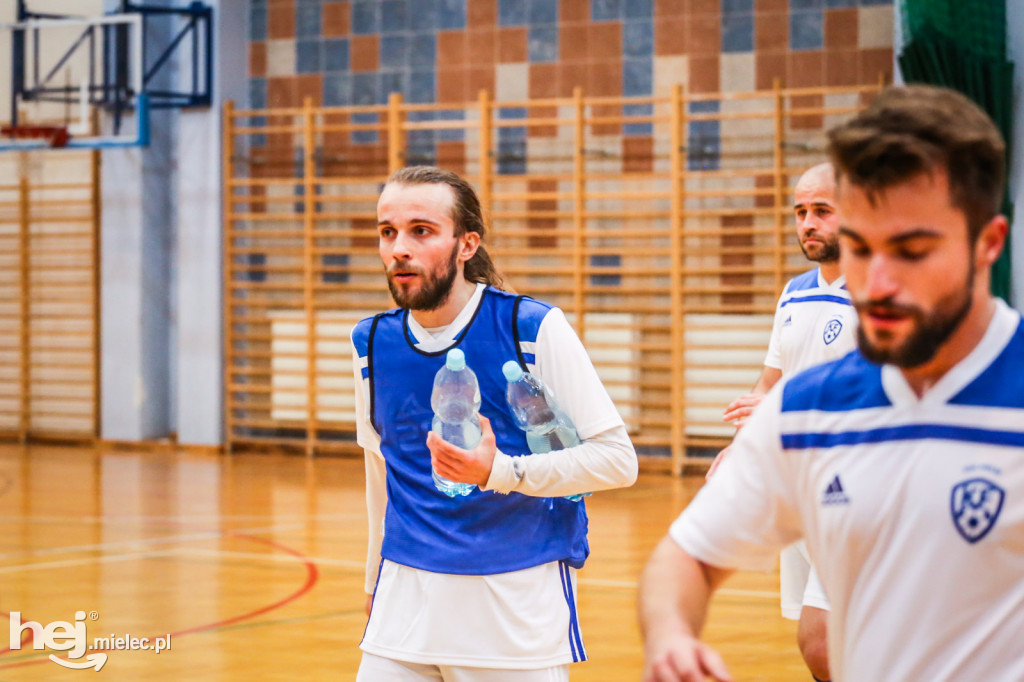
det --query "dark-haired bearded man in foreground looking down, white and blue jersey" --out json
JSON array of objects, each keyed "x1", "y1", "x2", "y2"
[{"x1": 639, "y1": 86, "x2": 1024, "y2": 682}]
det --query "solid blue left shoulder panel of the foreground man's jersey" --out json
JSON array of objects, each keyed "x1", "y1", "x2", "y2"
[{"x1": 782, "y1": 350, "x2": 892, "y2": 412}]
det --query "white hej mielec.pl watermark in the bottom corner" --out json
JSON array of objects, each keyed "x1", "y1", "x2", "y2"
[{"x1": 10, "y1": 611, "x2": 171, "y2": 672}]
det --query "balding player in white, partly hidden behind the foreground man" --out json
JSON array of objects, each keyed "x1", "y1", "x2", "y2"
[{"x1": 709, "y1": 163, "x2": 857, "y2": 682}]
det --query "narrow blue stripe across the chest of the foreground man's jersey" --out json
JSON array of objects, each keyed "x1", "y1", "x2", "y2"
[{"x1": 782, "y1": 424, "x2": 1024, "y2": 450}]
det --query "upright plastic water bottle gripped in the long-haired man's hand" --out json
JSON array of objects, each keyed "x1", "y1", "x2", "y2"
[{"x1": 430, "y1": 348, "x2": 480, "y2": 498}]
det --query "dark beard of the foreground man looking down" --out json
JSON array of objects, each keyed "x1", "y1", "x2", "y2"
[{"x1": 854, "y1": 262, "x2": 975, "y2": 370}]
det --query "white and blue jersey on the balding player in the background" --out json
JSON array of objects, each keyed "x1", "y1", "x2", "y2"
[{"x1": 765, "y1": 267, "x2": 857, "y2": 376}]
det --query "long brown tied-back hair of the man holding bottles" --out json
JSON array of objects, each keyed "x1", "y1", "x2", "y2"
[{"x1": 385, "y1": 166, "x2": 502, "y2": 289}]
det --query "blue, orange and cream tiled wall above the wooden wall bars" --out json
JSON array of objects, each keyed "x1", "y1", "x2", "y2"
[{"x1": 243, "y1": 0, "x2": 893, "y2": 112}]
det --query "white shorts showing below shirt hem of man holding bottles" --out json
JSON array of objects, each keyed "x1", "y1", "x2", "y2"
[{"x1": 355, "y1": 653, "x2": 569, "y2": 682}]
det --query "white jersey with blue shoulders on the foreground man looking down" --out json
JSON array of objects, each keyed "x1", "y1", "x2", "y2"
[{"x1": 671, "y1": 302, "x2": 1024, "y2": 682}]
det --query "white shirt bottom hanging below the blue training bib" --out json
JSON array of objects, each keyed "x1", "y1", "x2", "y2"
[{"x1": 359, "y1": 560, "x2": 587, "y2": 667}]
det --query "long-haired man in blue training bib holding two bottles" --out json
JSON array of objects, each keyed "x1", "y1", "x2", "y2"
[{"x1": 352, "y1": 167, "x2": 637, "y2": 682}]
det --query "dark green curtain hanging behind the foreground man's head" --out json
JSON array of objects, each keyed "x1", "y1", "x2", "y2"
[{"x1": 898, "y1": 0, "x2": 1014, "y2": 300}]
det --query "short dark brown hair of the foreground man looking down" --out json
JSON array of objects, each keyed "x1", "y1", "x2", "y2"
[{"x1": 828, "y1": 85, "x2": 1006, "y2": 244}]
